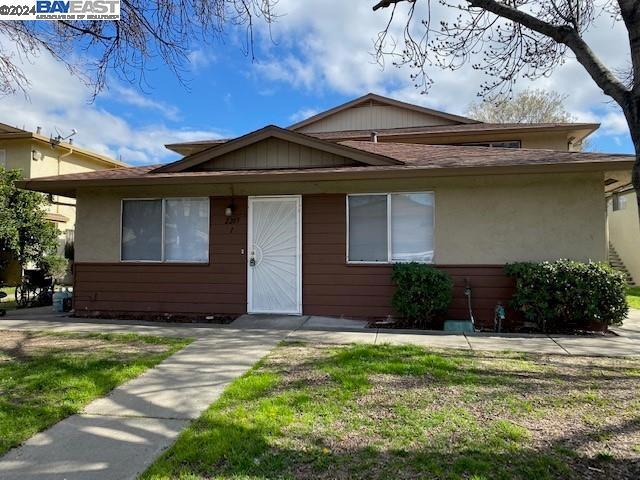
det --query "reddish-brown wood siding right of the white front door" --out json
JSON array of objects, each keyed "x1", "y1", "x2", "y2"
[{"x1": 302, "y1": 194, "x2": 513, "y2": 327}]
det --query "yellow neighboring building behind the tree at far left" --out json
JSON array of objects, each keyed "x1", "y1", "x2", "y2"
[{"x1": 0, "y1": 123, "x2": 127, "y2": 284}]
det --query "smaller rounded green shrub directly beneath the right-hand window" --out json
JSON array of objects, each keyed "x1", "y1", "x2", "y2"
[{"x1": 391, "y1": 262, "x2": 453, "y2": 327}]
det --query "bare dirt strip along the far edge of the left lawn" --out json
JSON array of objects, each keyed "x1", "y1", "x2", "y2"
[{"x1": 0, "y1": 330, "x2": 168, "y2": 361}]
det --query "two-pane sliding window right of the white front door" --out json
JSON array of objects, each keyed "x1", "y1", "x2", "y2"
[{"x1": 347, "y1": 192, "x2": 434, "y2": 263}]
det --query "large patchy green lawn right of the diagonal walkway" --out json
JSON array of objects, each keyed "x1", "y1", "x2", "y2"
[{"x1": 142, "y1": 344, "x2": 640, "y2": 480}]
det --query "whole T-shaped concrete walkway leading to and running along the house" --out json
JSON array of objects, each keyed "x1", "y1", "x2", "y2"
[{"x1": 0, "y1": 308, "x2": 640, "y2": 480}]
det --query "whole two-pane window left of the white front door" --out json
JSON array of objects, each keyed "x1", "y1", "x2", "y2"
[{"x1": 121, "y1": 198, "x2": 209, "y2": 262}]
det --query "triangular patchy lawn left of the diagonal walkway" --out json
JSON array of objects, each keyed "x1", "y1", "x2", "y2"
[{"x1": 0, "y1": 330, "x2": 190, "y2": 454}]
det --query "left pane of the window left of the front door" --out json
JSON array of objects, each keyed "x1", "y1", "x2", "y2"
[{"x1": 122, "y1": 200, "x2": 162, "y2": 261}]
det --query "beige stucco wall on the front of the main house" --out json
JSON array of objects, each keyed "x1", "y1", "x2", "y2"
[{"x1": 76, "y1": 173, "x2": 606, "y2": 264}]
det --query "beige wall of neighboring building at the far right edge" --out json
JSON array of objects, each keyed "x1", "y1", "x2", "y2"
[{"x1": 608, "y1": 192, "x2": 640, "y2": 284}]
